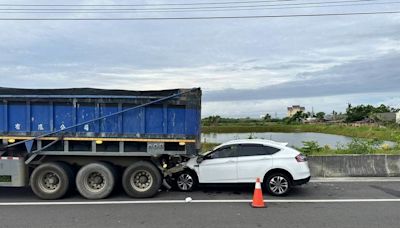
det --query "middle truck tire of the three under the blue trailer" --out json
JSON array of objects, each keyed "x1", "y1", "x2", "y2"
[{"x1": 76, "y1": 162, "x2": 116, "y2": 199}]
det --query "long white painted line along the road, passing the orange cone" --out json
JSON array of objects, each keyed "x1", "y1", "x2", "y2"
[{"x1": 0, "y1": 199, "x2": 400, "y2": 206}]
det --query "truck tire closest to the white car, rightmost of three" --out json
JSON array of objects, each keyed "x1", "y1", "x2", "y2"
[{"x1": 122, "y1": 161, "x2": 162, "y2": 198}]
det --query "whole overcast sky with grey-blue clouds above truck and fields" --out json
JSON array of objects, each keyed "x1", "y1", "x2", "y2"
[{"x1": 0, "y1": 0, "x2": 400, "y2": 117}]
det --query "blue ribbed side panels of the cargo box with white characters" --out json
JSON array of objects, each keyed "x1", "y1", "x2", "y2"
[{"x1": 0, "y1": 95, "x2": 199, "y2": 138}]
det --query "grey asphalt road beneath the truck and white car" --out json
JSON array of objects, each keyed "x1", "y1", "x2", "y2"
[{"x1": 0, "y1": 182, "x2": 400, "y2": 228}]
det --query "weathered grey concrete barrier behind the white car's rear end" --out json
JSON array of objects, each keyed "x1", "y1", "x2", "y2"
[{"x1": 308, "y1": 155, "x2": 400, "y2": 177}]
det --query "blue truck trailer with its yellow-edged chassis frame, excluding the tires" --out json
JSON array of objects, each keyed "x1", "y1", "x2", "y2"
[{"x1": 0, "y1": 88, "x2": 201, "y2": 198}]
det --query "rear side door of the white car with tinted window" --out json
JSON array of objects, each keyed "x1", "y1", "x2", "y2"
[{"x1": 237, "y1": 144, "x2": 279, "y2": 183}]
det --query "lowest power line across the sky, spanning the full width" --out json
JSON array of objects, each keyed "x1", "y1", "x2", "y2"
[{"x1": 0, "y1": 11, "x2": 400, "y2": 21}]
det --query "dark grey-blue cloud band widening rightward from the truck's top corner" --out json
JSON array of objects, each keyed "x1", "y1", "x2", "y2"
[{"x1": 205, "y1": 54, "x2": 400, "y2": 101}]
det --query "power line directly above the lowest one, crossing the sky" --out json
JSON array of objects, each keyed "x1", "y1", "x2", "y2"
[{"x1": 0, "y1": 1, "x2": 400, "y2": 14}]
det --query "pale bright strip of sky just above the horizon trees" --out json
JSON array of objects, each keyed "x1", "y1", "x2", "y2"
[{"x1": 202, "y1": 92, "x2": 400, "y2": 118}]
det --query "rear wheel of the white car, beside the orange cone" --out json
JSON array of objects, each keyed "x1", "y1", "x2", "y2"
[{"x1": 264, "y1": 173, "x2": 292, "y2": 196}]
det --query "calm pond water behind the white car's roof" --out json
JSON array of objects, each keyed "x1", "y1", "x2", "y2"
[{"x1": 201, "y1": 132, "x2": 393, "y2": 148}]
